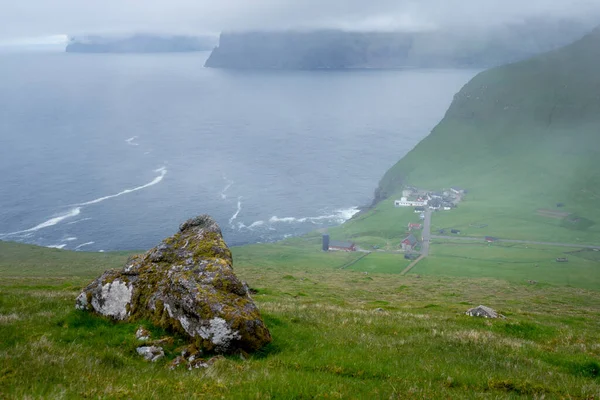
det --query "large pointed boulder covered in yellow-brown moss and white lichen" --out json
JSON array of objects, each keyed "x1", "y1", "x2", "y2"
[{"x1": 76, "y1": 215, "x2": 271, "y2": 353}]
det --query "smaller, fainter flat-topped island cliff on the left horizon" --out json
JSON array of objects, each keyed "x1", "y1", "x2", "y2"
[{"x1": 66, "y1": 35, "x2": 217, "y2": 53}]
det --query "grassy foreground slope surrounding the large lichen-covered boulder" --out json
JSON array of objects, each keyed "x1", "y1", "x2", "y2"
[{"x1": 0, "y1": 239, "x2": 600, "y2": 399}]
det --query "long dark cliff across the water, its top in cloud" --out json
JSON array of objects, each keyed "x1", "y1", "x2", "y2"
[{"x1": 206, "y1": 21, "x2": 591, "y2": 69}]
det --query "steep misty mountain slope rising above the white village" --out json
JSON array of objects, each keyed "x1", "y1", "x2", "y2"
[{"x1": 379, "y1": 28, "x2": 600, "y2": 202}]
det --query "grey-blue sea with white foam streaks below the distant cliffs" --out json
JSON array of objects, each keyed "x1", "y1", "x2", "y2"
[{"x1": 0, "y1": 53, "x2": 476, "y2": 251}]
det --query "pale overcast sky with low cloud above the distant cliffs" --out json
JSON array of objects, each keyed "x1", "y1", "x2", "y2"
[{"x1": 0, "y1": 0, "x2": 600, "y2": 42}]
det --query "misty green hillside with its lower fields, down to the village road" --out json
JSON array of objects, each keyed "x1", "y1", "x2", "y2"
[{"x1": 355, "y1": 25, "x2": 600, "y2": 244}]
